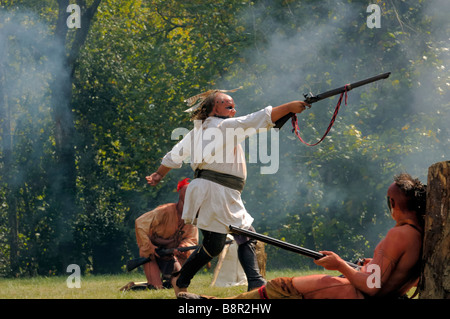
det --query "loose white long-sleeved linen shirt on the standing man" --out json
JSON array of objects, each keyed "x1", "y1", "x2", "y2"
[{"x1": 162, "y1": 106, "x2": 274, "y2": 234}]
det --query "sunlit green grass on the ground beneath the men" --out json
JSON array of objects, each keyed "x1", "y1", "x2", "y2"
[{"x1": 0, "y1": 270, "x2": 332, "y2": 299}]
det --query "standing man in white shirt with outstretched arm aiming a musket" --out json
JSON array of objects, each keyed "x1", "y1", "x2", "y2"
[{"x1": 146, "y1": 90, "x2": 309, "y2": 295}]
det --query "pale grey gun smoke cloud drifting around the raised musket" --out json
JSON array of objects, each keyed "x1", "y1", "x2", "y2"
[{"x1": 218, "y1": 1, "x2": 450, "y2": 264}]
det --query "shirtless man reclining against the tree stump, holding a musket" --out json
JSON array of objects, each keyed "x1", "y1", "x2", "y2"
[{"x1": 179, "y1": 174, "x2": 425, "y2": 299}]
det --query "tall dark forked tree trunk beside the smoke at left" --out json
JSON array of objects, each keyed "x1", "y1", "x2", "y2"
[{"x1": 50, "y1": 0, "x2": 101, "y2": 270}]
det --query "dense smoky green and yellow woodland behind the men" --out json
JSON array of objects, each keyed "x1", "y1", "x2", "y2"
[{"x1": 0, "y1": 0, "x2": 450, "y2": 276}]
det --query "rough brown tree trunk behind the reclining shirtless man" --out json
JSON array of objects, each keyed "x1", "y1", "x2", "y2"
[{"x1": 419, "y1": 161, "x2": 450, "y2": 299}]
